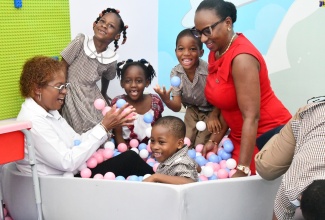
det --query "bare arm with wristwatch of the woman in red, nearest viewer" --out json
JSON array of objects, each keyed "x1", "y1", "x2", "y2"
[{"x1": 232, "y1": 54, "x2": 261, "y2": 177}]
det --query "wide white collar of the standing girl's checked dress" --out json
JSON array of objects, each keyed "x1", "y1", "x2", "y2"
[{"x1": 84, "y1": 35, "x2": 118, "y2": 64}]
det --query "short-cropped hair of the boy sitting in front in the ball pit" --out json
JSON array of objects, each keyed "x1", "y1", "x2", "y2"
[{"x1": 153, "y1": 116, "x2": 186, "y2": 138}]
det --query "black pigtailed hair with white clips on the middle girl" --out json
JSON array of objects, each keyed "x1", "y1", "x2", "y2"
[{"x1": 116, "y1": 59, "x2": 156, "y2": 83}]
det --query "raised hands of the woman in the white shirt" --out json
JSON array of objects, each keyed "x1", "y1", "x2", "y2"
[{"x1": 102, "y1": 103, "x2": 136, "y2": 130}]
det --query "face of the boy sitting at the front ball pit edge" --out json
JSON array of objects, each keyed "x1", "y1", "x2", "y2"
[{"x1": 150, "y1": 125, "x2": 184, "y2": 163}]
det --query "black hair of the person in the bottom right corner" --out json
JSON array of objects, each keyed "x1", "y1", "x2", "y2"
[{"x1": 300, "y1": 180, "x2": 325, "y2": 220}]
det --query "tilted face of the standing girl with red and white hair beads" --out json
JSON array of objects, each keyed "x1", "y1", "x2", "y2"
[{"x1": 94, "y1": 13, "x2": 120, "y2": 43}]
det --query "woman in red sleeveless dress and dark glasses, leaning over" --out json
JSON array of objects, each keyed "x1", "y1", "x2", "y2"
[{"x1": 192, "y1": 0, "x2": 291, "y2": 177}]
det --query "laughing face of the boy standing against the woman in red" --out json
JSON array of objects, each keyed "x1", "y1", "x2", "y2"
[{"x1": 175, "y1": 36, "x2": 203, "y2": 71}]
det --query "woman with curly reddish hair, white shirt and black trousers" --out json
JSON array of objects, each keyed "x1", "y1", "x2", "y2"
[{"x1": 17, "y1": 56, "x2": 153, "y2": 177}]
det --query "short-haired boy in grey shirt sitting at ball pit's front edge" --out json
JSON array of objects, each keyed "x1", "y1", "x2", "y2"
[{"x1": 143, "y1": 116, "x2": 201, "y2": 184}]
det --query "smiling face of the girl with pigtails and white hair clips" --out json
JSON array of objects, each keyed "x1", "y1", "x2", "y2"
[{"x1": 121, "y1": 66, "x2": 149, "y2": 101}]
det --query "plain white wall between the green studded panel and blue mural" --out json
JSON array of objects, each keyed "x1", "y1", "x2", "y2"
[{"x1": 70, "y1": 0, "x2": 158, "y2": 98}]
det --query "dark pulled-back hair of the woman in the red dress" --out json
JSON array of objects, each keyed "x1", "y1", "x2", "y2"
[{"x1": 195, "y1": 0, "x2": 237, "y2": 23}]
